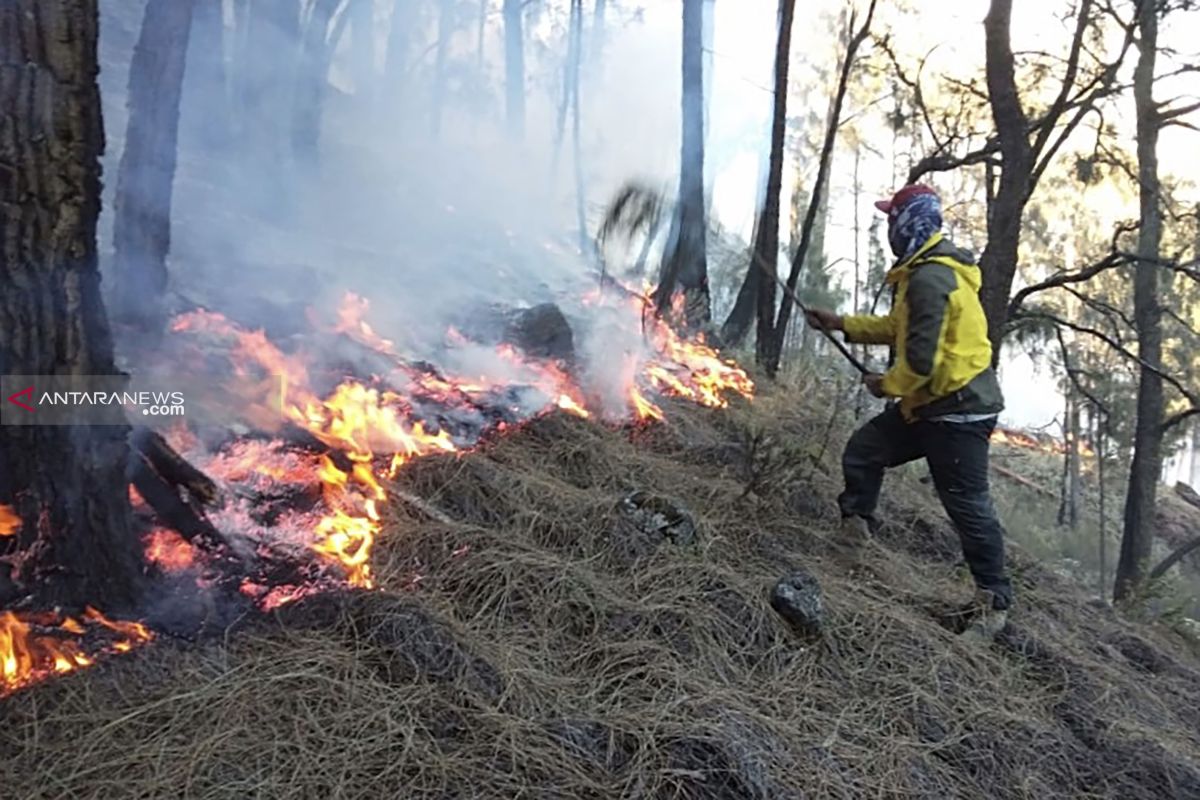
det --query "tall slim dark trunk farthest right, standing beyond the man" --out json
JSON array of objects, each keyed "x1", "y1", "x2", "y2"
[{"x1": 1114, "y1": 4, "x2": 1163, "y2": 600}]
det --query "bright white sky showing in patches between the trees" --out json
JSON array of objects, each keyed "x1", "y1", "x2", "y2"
[{"x1": 623, "y1": 0, "x2": 1200, "y2": 438}]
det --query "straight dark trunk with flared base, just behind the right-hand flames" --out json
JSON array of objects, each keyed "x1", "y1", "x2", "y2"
[{"x1": 658, "y1": 0, "x2": 712, "y2": 330}]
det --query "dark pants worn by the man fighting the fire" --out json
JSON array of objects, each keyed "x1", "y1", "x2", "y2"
[{"x1": 838, "y1": 404, "x2": 1013, "y2": 608}]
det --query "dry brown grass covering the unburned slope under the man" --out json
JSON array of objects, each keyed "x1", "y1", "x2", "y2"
[{"x1": 0, "y1": 386, "x2": 1200, "y2": 800}]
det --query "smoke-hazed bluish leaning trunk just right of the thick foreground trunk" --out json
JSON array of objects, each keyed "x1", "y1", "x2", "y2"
[{"x1": 113, "y1": 0, "x2": 192, "y2": 337}]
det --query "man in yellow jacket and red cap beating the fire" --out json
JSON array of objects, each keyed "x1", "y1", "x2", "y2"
[{"x1": 806, "y1": 185, "x2": 1013, "y2": 639}]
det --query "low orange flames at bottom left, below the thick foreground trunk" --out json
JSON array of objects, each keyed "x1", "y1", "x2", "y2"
[{"x1": 0, "y1": 606, "x2": 152, "y2": 694}]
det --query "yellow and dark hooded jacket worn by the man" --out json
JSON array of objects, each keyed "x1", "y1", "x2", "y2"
[{"x1": 842, "y1": 233, "x2": 1004, "y2": 422}]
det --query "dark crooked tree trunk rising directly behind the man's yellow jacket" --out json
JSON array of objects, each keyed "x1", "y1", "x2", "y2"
[{"x1": 979, "y1": 0, "x2": 1033, "y2": 363}]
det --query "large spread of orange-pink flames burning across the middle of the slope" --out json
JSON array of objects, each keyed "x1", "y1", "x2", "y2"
[{"x1": 164, "y1": 287, "x2": 754, "y2": 594}]
